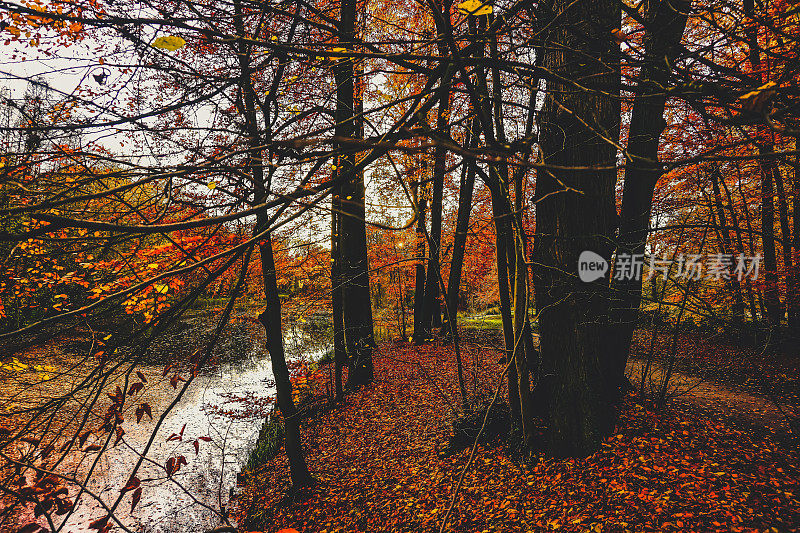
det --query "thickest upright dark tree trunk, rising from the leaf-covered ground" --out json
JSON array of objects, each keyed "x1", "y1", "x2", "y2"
[{"x1": 534, "y1": 0, "x2": 621, "y2": 456}]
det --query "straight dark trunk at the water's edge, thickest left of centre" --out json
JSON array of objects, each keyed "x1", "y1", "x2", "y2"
[{"x1": 333, "y1": 0, "x2": 375, "y2": 388}]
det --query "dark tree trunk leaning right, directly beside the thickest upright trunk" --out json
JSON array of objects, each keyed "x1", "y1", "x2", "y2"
[{"x1": 605, "y1": 0, "x2": 691, "y2": 391}]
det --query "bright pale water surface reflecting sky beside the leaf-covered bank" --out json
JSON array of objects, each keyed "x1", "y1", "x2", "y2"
[{"x1": 57, "y1": 325, "x2": 328, "y2": 533}]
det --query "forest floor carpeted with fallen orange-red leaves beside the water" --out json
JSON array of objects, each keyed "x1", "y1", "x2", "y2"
[{"x1": 238, "y1": 332, "x2": 800, "y2": 533}]
